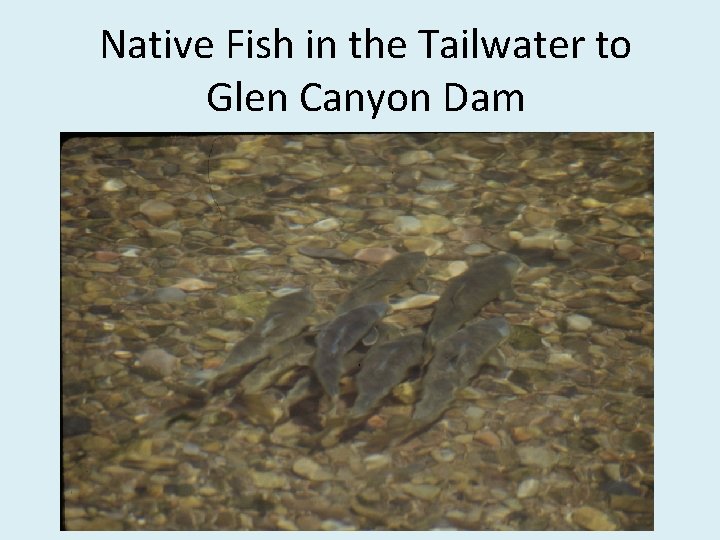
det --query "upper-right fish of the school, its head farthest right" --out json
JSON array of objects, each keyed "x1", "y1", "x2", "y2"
[{"x1": 425, "y1": 254, "x2": 520, "y2": 350}]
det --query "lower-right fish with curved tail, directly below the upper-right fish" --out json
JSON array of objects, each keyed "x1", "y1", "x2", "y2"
[{"x1": 368, "y1": 317, "x2": 510, "y2": 450}]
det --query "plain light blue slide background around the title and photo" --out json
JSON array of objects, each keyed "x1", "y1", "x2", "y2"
[{"x1": 0, "y1": 0, "x2": 720, "y2": 538}]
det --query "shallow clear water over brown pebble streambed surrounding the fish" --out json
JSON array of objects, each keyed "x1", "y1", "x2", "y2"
[{"x1": 60, "y1": 133, "x2": 654, "y2": 530}]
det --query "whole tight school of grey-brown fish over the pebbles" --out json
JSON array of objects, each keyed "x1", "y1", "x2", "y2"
[{"x1": 186, "y1": 252, "x2": 521, "y2": 449}]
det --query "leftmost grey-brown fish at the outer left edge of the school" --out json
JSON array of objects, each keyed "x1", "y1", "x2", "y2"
[{"x1": 206, "y1": 288, "x2": 315, "y2": 387}]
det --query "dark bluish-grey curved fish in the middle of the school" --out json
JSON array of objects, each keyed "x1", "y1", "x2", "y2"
[{"x1": 312, "y1": 303, "x2": 390, "y2": 402}]
